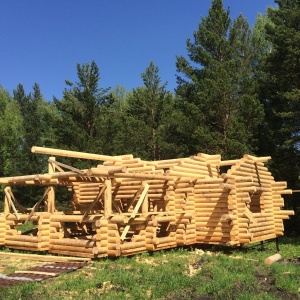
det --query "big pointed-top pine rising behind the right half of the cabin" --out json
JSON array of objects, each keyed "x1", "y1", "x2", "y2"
[{"x1": 176, "y1": 0, "x2": 263, "y2": 158}]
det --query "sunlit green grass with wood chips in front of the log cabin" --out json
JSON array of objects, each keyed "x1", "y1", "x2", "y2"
[{"x1": 0, "y1": 238, "x2": 300, "y2": 300}]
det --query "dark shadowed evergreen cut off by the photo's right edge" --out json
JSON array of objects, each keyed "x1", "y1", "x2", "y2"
[{"x1": 261, "y1": 0, "x2": 300, "y2": 222}]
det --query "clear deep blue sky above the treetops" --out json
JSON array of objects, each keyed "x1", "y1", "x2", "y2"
[{"x1": 0, "y1": 0, "x2": 275, "y2": 101}]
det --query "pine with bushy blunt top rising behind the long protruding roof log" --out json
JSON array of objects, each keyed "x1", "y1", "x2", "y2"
[{"x1": 54, "y1": 61, "x2": 109, "y2": 153}]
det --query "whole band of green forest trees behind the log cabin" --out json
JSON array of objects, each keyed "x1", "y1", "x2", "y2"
[{"x1": 0, "y1": 0, "x2": 300, "y2": 234}]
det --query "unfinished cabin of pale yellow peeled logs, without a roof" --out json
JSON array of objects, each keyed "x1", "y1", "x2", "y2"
[{"x1": 0, "y1": 146, "x2": 294, "y2": 258}]
